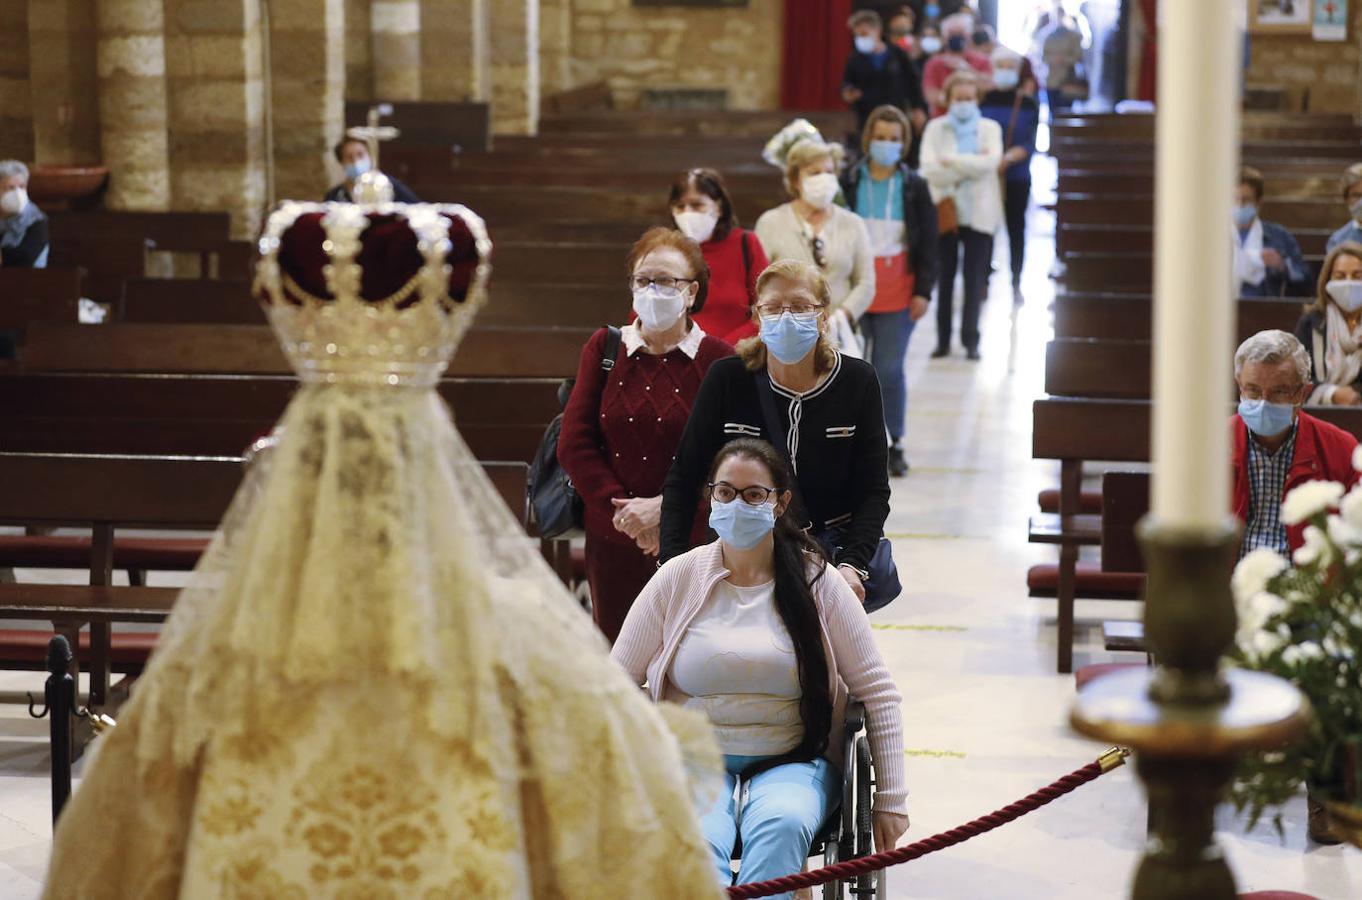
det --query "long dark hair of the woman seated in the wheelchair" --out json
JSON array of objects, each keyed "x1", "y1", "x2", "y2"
[{"x1": 708, "y1": 437, "x2": 832, "y2": 777}]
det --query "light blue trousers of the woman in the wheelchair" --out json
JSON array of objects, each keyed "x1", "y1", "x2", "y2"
[{"x1": 700, "y1": 756, "x2": 842, "y2": 900}]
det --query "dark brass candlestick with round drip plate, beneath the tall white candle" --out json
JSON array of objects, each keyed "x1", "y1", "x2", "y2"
[{"x1": 1069, "y1": 520, "x2": 1310, "y2": 900}]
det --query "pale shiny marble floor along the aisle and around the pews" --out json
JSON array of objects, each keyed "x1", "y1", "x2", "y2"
[{"x1": 0, "y1": 158, "x2": 1362, "y2": 900}]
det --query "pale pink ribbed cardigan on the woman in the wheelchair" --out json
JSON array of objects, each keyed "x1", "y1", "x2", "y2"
[{"x1": 610, "y1": 541, "x2": 908, "y2": 814}]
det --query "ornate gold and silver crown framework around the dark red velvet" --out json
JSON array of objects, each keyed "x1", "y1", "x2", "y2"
[{"x1": 255, "y1": 202, "x2": 492, "y2": 387}]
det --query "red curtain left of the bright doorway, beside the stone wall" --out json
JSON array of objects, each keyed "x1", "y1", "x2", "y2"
[{"x1": 780, "y1": 0, "x2": 851, "y2": 109}]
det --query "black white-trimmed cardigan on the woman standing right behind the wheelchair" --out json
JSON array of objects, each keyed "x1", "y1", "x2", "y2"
[{"x1": 659, "y1": 354, "x2": 889, "y2": 570}]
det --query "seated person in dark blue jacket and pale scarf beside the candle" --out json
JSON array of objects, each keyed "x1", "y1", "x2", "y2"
[{"x1": 1234, "y1": 166, "x2": 1313, "y2": 297}]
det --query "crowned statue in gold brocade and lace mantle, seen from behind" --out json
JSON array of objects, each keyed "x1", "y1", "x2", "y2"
[{"x1": 45, "y1": 203, "x2": 718, "y2": 900}]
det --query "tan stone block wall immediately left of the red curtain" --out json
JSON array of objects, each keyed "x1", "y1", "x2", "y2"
[{"x1": 563, "y1": 0, "x2": 785, "y2": 109}]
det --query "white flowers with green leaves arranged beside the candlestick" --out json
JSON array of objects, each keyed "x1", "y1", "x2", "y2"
[{"x1": 1231, "y1": 448, "x2": 1362, "y2": 832}]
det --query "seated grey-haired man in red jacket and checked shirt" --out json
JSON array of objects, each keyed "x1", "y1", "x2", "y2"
[{"x1": 1230, "y1": 330, "x2": 1358, "y2": 557}]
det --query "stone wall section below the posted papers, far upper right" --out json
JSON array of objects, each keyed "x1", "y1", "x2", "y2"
[{"x1": 1248, "y1": 7, "x2": 1362, "y2": 116}]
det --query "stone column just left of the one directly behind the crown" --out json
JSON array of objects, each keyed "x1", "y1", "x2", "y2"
[{"x1": 163, "y1": 0, "x2": 266, "y2": 238}]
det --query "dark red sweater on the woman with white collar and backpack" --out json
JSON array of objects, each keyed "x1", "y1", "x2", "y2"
[{"x1": 558, "y1": 328, "x2": 733, "y2": 543}]
